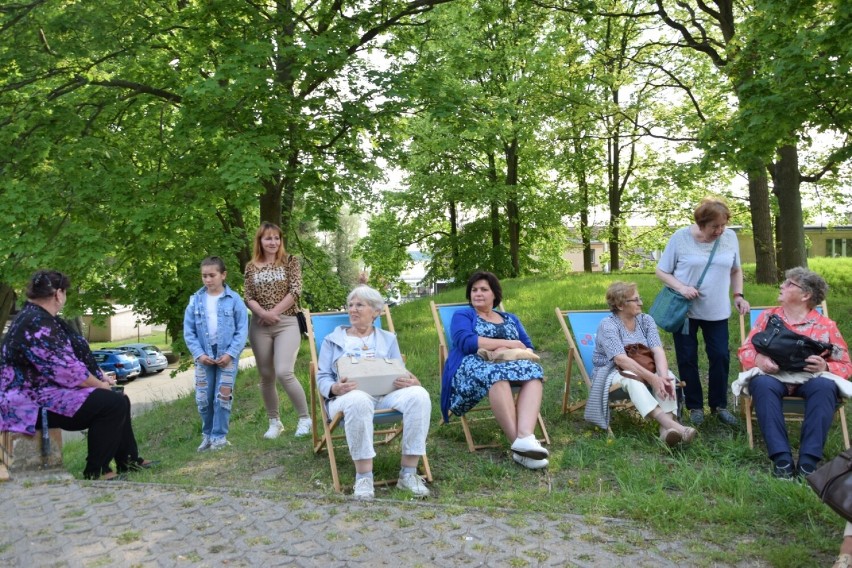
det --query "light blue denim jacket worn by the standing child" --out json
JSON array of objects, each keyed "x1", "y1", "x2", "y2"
[{"x1": 183, "y1": 284, "x2": 248, "y2": 361}]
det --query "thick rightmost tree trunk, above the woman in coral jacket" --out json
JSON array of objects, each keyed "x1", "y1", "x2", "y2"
[{"x1": 773, "y1": 145, "x2": 808, "y2": 272}]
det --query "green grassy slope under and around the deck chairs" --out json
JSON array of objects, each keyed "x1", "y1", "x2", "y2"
[{"x1": 65, "y1": 274, "x2": 852, "y2": 567}]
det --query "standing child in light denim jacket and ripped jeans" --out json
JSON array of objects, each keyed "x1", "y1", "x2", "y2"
[{"x1": 183, "y1": 256, "x2": 248, "y2": 452}]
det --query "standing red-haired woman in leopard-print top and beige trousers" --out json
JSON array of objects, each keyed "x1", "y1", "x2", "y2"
[{"x1": 245, "y1": 222, "x2": 311, "y2": 440}]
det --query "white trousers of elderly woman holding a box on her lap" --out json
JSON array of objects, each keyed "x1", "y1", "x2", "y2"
[{"x1": 328, "y1": 386, "x2": 432, "y2": 460}]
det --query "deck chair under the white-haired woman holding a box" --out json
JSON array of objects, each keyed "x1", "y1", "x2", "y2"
[{"x1": 305, "y1": 306, "x2": 432, "y2": 492}]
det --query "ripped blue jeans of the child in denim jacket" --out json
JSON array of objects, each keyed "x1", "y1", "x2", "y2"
[{"x1": 195, "y1": 345, "x2": 239, "y2": 440}]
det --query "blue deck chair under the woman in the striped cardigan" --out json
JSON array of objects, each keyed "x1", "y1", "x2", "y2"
[{"x1": 556, "y1": 308, "x2": 633, "y2": 415}]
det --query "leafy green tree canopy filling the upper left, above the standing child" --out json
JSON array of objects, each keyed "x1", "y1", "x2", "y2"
[{"x1": 0, "y1": 0, "x2": 447, "y2": 330}]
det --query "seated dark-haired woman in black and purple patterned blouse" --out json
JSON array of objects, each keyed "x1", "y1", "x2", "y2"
[{"x1": 0, "y1": 270, "x2": 151, "y2": 480}]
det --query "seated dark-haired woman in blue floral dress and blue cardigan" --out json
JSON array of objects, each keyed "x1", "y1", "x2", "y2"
[{"x1": 441, "y1": 272, "x2": 549, "y2": 469}]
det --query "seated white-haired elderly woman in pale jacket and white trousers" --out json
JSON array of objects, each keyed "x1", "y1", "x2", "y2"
[{"x1": 317, "y1": 286, "x2": 432, "y2": 500}]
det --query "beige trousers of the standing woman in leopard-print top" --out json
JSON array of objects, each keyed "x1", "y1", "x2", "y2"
[{"x1": 249, "y1": 316, "x2": 309, "y2": 419}]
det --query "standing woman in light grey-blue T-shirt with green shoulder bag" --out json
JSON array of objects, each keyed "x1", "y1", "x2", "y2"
[{"x1": 656, "y1": 198, "x2": 749, "y2": 426}]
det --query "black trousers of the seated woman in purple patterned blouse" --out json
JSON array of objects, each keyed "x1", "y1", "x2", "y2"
[{"x1": 36, "y1": 389, "x2": 139, "y2": 479}]
